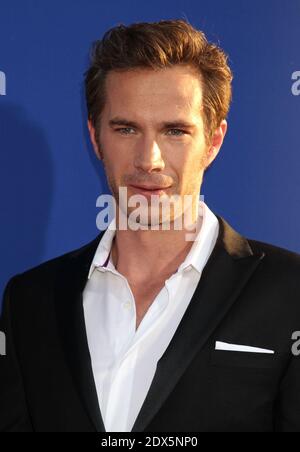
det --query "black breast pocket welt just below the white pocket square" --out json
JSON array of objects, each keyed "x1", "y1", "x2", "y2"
[{"x1": 210, "y1": 350, "x2": 281, "y2": 369}]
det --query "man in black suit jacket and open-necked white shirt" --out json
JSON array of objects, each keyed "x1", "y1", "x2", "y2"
[{"x1": 0, "y1": 20, "x2": 300, "y2": 432}]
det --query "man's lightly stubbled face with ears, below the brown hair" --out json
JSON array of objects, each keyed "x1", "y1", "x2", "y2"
[{"x1": 89, "y1": 66, "x2": 226, "y2": 226}]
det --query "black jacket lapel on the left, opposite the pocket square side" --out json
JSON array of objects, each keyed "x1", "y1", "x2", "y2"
[{"x1": 54, "y1": 232, "x2": 105, "y2": 432}]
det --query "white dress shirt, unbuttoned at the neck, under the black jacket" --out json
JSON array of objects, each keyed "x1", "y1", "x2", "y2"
[{"x1": 83, "y1": 200, "x2": 219, "y2": 432}]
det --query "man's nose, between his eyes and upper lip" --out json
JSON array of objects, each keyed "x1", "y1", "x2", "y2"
[{"x1": 134, "y1": 138, "x2": 165, "y2": 173}]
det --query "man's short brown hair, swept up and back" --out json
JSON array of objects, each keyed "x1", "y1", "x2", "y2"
[{"x1": 84, "y1": 19, "x2": 233, "y2": 144}]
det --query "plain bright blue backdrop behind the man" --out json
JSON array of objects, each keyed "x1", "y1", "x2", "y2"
[{"x1": 0, "y1": 0, "x2": 300, "y2": 308}]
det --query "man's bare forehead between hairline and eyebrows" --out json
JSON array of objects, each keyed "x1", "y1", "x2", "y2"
[{"x1": 106, "y1": 65, "x2": 202, "y2": 117}]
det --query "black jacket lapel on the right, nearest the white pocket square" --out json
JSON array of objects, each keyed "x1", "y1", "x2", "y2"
[{"x1": 132, "y1": 216, "x2": 264, "y2": 432}]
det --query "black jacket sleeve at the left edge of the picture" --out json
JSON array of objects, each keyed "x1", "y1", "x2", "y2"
[{"x1": 0, "y1": 276, "x2": 33, "y2": 432}]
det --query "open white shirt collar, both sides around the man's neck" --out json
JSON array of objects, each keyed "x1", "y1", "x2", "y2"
[{"x1": 88, "y1": 200, "x2": 219, "y2": 279}]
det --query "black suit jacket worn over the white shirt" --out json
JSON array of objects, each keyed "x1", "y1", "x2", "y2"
[{"x1": 0, "y1": 216, "x2": 300, "y2": 432}]
